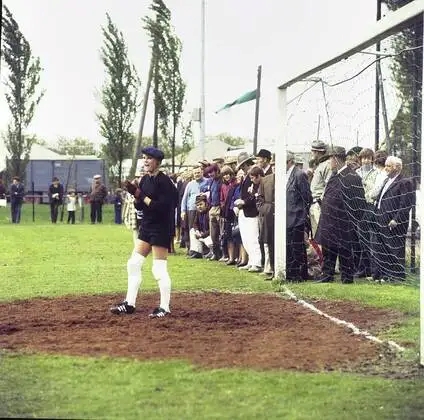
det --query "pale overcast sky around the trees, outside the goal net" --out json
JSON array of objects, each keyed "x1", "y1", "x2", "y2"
[{"x1": 0, "y1": 0, "x2": 376, "y2": 151}]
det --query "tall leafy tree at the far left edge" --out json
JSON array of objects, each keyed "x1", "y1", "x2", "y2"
[{"x1": 2, "y1": 6, "x2": 44, "y2": 178}]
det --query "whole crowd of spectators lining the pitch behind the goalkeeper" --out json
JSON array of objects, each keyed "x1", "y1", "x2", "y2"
[{"x1": 0, "y1": 140, "x2": 416, "y2": 284}]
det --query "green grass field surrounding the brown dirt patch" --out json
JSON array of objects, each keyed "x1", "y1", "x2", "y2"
[{"x1": 0, "y1": 206, "x2": 424, "y2": 420}]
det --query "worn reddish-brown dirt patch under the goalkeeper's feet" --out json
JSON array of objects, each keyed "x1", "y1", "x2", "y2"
[{"x1": 0, "y1": 293, "x2": 399, "y2": 372}]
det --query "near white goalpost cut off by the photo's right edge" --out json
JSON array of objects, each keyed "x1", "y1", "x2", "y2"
[{"x1": 417, "y1": 10, "x2": 424, "y2": 366}]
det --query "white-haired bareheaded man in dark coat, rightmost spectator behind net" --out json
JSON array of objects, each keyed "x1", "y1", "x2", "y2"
[{"x1": 371, "y1": 156, "x2": 416, "y2": 281}]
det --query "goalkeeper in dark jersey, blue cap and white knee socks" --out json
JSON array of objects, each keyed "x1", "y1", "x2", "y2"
[{"x1": 110, "y1": 147, "x2": 178, "y2": 318}]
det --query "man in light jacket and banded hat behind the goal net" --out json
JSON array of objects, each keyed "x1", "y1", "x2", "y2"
[{"x1": 310, "y1": 140, "x2": 331, "y2": 235}]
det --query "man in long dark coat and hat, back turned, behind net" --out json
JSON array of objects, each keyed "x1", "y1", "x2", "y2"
[{"x1": 315, "y1": 146, "x2": 366, "y2": 283}]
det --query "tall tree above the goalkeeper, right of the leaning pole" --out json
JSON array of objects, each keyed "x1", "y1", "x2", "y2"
[{"x1": 143, "y1": 0, "x2": 186, "y2": 170}]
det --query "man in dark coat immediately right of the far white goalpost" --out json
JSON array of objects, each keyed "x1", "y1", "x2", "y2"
[{"x1": 286, "y1": 152, "x2": 312, "y2": 281}]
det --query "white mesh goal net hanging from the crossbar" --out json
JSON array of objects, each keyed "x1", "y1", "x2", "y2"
[{"x1": 287, "y1": 23, "x2": 423, "y2": 285}]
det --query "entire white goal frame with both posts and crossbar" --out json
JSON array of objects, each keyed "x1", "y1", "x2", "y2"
[{"x1": 275, "y1": 0, "x2": 424, "y2": 365}]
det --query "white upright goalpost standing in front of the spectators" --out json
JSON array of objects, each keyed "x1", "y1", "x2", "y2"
[{"x1": 274, "y1": 89, "x2": 287, "y2": 280}]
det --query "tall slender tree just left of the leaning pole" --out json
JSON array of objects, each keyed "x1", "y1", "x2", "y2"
[{"x1": 97, "y1": 14, "x2": 140, "y2": 183}]
